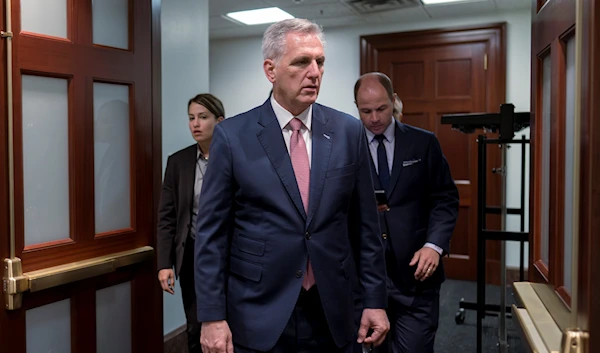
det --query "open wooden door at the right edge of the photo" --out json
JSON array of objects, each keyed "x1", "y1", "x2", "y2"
[{"x1": 530, "y1": 0, "x2": 600, "y2": 352}]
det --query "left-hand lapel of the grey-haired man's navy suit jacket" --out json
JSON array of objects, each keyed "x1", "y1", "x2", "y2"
[{"x1": 257, "y1": 100, "x2": 314, "y2": 219}]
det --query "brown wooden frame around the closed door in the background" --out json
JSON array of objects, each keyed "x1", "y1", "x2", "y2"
[{"x1": 360, "y1": 22, "x2": 506, "y2": 284}]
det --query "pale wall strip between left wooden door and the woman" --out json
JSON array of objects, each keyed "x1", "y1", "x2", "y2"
[{"x1": 161, "y1": 0, "x2": 209, "y2": 334}]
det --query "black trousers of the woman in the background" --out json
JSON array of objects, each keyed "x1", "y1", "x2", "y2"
[{"x1": 179, "y1": 237, "x2": 202, "y2": 353}]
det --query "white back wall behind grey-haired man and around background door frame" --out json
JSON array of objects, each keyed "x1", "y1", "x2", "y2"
[{"x1": 210, "y1": 10, "x2": 531, "y2": 266}]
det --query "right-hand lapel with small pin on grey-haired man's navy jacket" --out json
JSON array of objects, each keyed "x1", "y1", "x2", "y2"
[{"x1": 306, "y1": 104, "x2": 334, "y2": 227}]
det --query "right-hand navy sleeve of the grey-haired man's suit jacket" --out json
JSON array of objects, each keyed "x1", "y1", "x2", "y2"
[{"x1": 350, "y1": 124, "x2": 387, "y2": 309}]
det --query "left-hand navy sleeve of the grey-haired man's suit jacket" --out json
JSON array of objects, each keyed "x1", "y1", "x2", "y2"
[{"x1": 194, "y1": 125, "x2": 234, "y2": 322}]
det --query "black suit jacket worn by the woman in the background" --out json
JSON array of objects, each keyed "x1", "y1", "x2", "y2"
[{"x1": 157, "y1": 144, "x2": 198, "y2": 275}]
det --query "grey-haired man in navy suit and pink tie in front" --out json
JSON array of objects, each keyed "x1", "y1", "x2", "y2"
[{"x1": 195, "y1": 19, "x2": 389, "y2": 353}]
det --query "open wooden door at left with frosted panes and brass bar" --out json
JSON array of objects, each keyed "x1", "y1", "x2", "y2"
[{"x1": 0, "y1": 0, "x2": 163, "y2": 353}]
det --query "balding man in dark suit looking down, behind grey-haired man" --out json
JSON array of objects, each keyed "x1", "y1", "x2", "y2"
[{"x1": 354, "y1": 73, "x2": 458, "y2": 353}]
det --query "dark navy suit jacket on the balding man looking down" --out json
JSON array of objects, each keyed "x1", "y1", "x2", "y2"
[{"x1": 371, "y1": 120, "x2": 466, "y2": 293}]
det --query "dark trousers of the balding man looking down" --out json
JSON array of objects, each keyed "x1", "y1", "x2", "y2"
[{"x1": 377, "y1": 286, "x2": 440, "y2": 353}]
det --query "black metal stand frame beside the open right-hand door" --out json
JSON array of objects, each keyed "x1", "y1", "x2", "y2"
[{"x1": 442, "y1": 104, "x2": 530, "y2": 353}]
